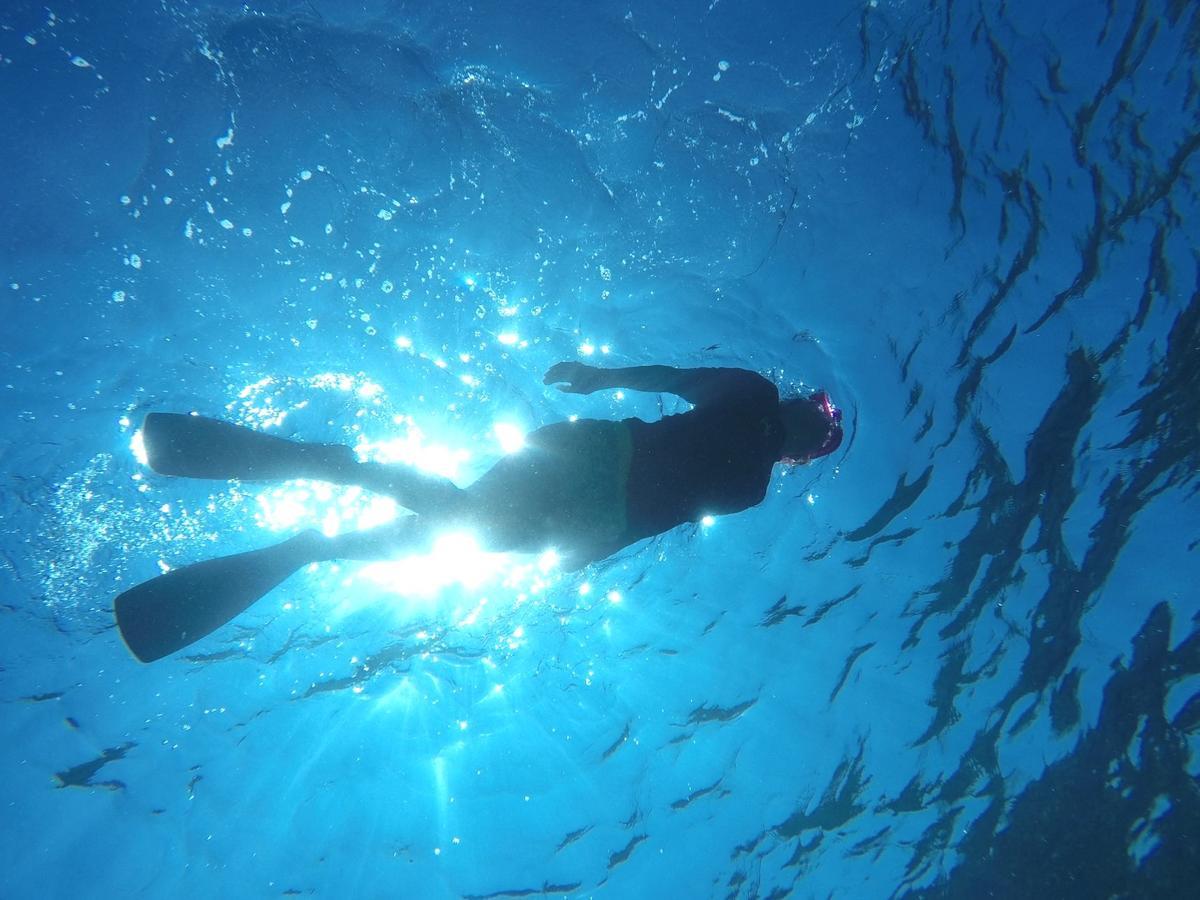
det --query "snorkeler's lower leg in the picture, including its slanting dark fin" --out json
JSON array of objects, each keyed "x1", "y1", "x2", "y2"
[{"x1": 114, "y1": 516, "x2": 428, "y2": 662}]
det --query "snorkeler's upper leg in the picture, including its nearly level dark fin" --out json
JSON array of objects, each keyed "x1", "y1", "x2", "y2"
[{"x1": 142, "y1": 413, "x2": 462, "y2": 515}]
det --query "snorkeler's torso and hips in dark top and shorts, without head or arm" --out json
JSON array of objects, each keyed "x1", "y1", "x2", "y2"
[{"x1": 468, "y1": 372, "x2": 784, "y2": 568}]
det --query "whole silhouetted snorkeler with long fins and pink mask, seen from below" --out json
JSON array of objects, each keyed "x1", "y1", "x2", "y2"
[{"x1": 115, "y1": 362, "x2": 842, "y2": 662}]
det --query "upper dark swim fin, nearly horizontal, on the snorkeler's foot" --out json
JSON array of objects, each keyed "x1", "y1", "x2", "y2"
[{"x1": 142, "y1": 413, "x2": 358, "y2": 481}]
